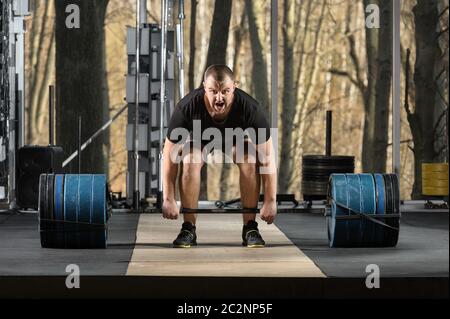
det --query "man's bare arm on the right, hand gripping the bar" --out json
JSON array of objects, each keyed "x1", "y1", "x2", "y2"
[{"x1": 256, "y1": 137, "x2": 278, "y2": 224}]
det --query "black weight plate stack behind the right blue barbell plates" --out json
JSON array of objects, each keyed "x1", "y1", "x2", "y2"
[{"x1": 302, "y1": 155, "x2": 355, "y2": 201}]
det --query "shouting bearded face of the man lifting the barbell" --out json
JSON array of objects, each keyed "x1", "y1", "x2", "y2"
[{"x1": 203, "y1": 76, "x2": 236, "y2": 119}]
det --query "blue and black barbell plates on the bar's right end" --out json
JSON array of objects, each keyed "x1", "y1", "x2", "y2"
[{"x1": 325, "y1": 174, "x2": 400, "y2": 247}]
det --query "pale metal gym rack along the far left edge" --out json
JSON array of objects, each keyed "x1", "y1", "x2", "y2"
[{"x1": 0, "y1": 0, "x2": 30, "y2": 209}]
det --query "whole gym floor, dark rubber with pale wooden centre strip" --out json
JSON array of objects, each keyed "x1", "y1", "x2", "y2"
[{"x1": 0, "y1": 211, "x2": 449, "y2": 298}]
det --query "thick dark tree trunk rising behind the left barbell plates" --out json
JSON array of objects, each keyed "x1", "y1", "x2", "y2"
[{"x1": 55, "y1": 0, "x2": 108, "y2": 173}]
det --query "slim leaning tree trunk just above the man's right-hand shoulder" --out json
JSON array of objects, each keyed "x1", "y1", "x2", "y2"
[{"x1": 245, "y1": 0, "x2": 270, "y2": 118}]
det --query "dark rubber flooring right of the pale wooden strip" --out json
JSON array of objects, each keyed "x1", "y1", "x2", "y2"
[{"x1": 276, "y1": 212, "x2": 449, "y2": 278}]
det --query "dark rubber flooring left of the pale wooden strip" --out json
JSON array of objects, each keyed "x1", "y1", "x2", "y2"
[{"x1": 0, "y1": 214, "x2": 139, "y2": 276}]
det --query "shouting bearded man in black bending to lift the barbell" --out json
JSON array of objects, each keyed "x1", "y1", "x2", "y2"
[{"x1": 162, "y1": 65, "x2": 277, "y2": 248}]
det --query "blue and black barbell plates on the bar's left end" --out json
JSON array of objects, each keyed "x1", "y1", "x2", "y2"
[{"x1": 39, "y1": 174, "x2": 109, "y2": 248}]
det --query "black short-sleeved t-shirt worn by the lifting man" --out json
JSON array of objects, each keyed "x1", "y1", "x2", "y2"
[{"x1": 167, "y1": 88, "x2": 270, "y2": 146}]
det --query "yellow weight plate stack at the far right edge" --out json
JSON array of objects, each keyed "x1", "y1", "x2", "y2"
[{"x1": 422, "y1": 163, "x2": 448, "y2": 197}]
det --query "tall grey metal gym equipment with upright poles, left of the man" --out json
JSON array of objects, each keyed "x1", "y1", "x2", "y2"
[{"x1": 126, "y1": 0, "x2": 176, "y2": 211}]
